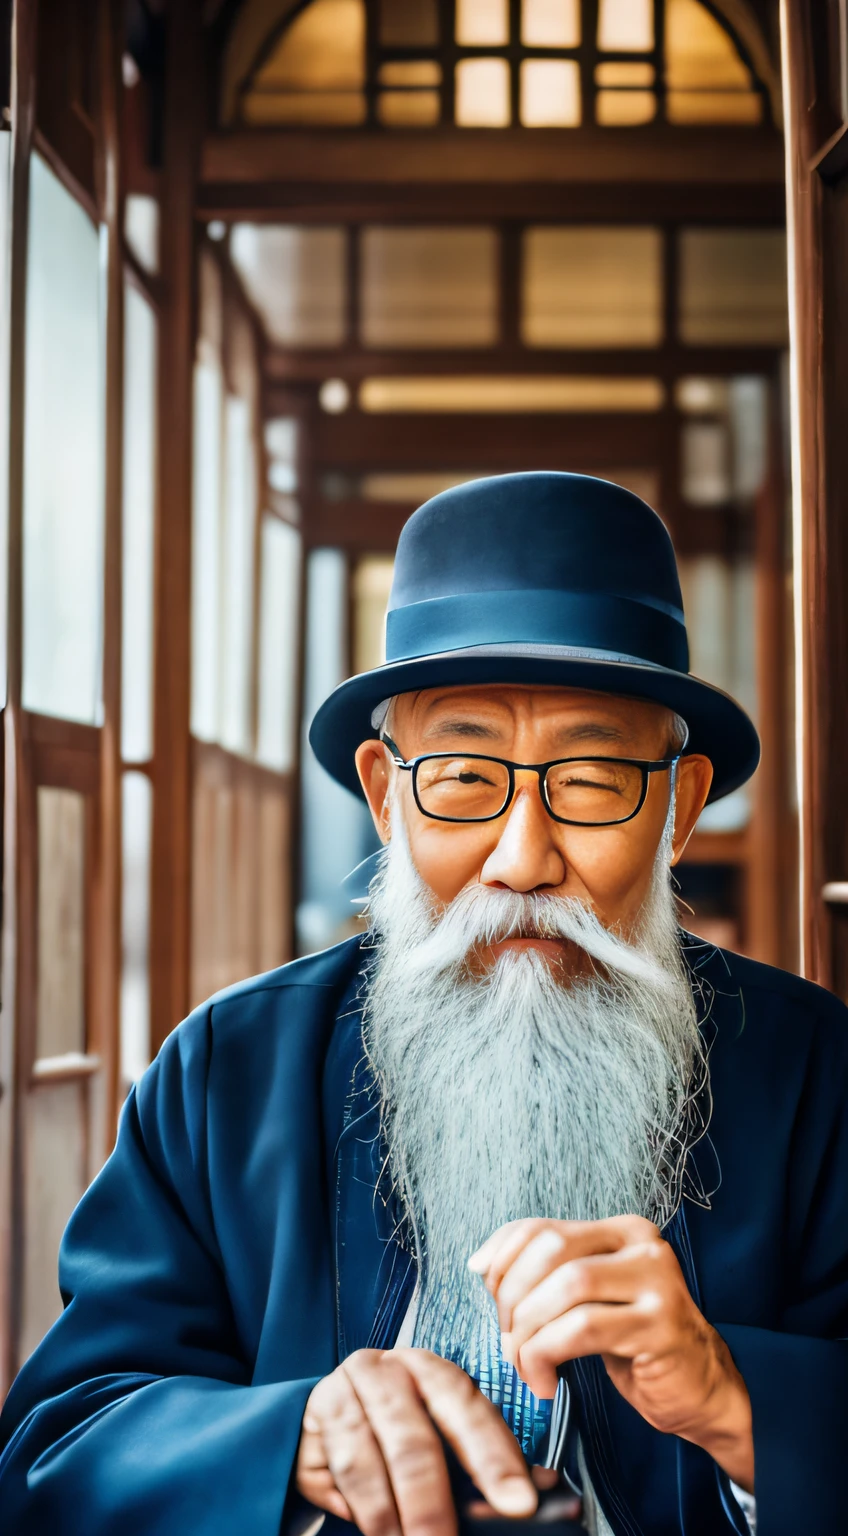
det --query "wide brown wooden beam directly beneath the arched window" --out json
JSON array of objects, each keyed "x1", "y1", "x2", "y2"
[{"x1": 200, "y1": 126, "x2": 783, "y2": 187}]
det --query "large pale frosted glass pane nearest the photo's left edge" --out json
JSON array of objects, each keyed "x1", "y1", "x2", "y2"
[{"x1": 23, "y1": 155, "x2": 103, "y2": 722}]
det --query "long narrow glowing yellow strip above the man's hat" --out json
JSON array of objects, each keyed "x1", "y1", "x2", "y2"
[{"x1": 359, "y1": 375, "x2": 665, "y2": 415}]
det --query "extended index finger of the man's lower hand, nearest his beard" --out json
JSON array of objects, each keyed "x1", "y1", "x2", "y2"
[{"x1": 395, "y1": 1349, "x2": 538, "y2": 1516}]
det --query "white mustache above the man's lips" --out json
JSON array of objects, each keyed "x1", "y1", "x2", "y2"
[{"x1": 384, "y1": 885, "x2": 673, "y2": 988}]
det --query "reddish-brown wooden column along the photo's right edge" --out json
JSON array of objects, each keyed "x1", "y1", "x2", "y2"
[{"x1": 782, "y1": 0, "x2": 848, "y2": 997}]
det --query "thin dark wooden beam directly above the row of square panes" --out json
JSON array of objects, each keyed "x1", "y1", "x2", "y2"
[{"x1": 197, "y1": 172, "x2": 787, "y2": 224}]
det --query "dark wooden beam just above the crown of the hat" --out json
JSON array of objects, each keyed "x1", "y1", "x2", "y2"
[{"x1": 304, "y1": 405, "x2": 661, "y2": 472}]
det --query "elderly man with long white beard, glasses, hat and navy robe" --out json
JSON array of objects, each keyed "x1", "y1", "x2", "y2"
[{"x1": 0, "y1": 475, "x2": 848, "y2": 1536}]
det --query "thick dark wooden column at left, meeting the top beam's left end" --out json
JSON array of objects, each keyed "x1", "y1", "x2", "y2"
[{"x1": 151, "y1": 0, "x2": 203, "y2": 1051}]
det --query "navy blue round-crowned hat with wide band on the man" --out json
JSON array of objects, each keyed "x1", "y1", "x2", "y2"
[{"x1": 309, "y1": 472, "x2": 760, "y2": 800}]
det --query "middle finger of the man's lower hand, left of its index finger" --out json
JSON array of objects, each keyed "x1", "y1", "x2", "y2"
[{"x1": 345, "y1": 1352, "x2": 461, "y2": 1536}]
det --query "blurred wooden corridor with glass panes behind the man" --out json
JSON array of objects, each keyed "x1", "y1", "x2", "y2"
[{"x1": 0, "y1": 0, "x2": 845, "y2": 1394}]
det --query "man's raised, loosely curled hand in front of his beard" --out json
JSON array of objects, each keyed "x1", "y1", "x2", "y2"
[{"x1": 470, "y1": 1217, "x2": 754, "y2": 1491}]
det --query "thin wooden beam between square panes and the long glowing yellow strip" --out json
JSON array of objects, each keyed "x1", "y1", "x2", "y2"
[{"x1": 264, "y1": 346, "x2": 780, "y2": 384}]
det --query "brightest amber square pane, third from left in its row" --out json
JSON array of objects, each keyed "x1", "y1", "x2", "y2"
[{"x1": 521, "y1": 226, "x2": 662, "y2": 347}]
